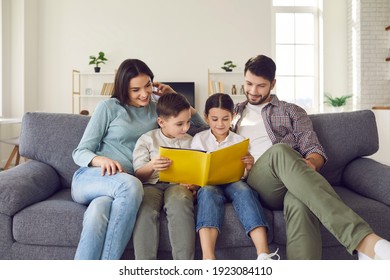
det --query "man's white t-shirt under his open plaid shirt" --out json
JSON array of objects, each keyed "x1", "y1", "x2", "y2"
[{"x1": 237, "y1": 103, "x2": 272, "y2": 161}]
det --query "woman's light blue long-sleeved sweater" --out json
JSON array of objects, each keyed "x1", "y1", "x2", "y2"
[{"x1": 72, "y1": 98, "x2": 203, "y2": 174}]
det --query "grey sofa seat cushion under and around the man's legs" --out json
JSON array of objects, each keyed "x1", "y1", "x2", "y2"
[{"x1": 274, "y1": 187, "x2": 390, "y2": 247}]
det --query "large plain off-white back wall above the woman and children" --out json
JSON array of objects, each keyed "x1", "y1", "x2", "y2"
[{"x1": 37, "y1": 0, "x2": 272, "y2": 113}]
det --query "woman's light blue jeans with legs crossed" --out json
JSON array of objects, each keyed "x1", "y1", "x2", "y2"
[{"x1": 72, "y1": 167, "x2": 143, "y2": 260}]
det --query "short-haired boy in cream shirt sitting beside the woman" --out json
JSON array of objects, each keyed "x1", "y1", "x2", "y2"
[{"x1": 133, "y1": 94, "x2": 195, "y2": 260}]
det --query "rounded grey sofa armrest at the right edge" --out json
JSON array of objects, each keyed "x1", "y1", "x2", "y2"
[{"x1": 342, "y1": 158, "x2": 390, "y2": 205}]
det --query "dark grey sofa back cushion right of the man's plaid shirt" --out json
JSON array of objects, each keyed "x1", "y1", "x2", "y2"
[{"x1": 310, "y1": 110, "x2": 379, "y2": 185}]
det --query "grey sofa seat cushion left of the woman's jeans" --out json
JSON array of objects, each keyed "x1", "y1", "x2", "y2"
[{"x1": 13, "y1": 189, "x2": 86, "y2": 247}]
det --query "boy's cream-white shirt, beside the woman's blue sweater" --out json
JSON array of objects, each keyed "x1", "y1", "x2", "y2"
[{"x1": 133, "y1": 128, "x2": 192, "y2": 184}]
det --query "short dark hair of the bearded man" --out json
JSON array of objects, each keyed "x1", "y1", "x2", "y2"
[{"x1": 244, "y1": 55, "x2": 276, "y2": 82}]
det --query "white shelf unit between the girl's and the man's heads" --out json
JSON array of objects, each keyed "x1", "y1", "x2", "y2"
[{"x1": 208, "y1": 69, "x2": 246, "y2": 102}]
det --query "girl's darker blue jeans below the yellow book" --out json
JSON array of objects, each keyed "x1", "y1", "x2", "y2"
[{"x1": 196, "y1": 181, "x2": 269, "y2": 234}]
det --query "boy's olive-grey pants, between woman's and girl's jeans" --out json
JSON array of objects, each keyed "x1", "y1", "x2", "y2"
[{"x1": 133, "y1": 183, "x2": 195, "y2": 260}]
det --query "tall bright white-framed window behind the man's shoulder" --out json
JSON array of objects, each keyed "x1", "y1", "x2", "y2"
[{"x1": 273, "y1": 0, "x2": 322, "y2": 112}]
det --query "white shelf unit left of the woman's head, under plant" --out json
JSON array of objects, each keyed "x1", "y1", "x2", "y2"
[{"x1": 72, "y1": 69, "x2": 115, "y2": 114}]
